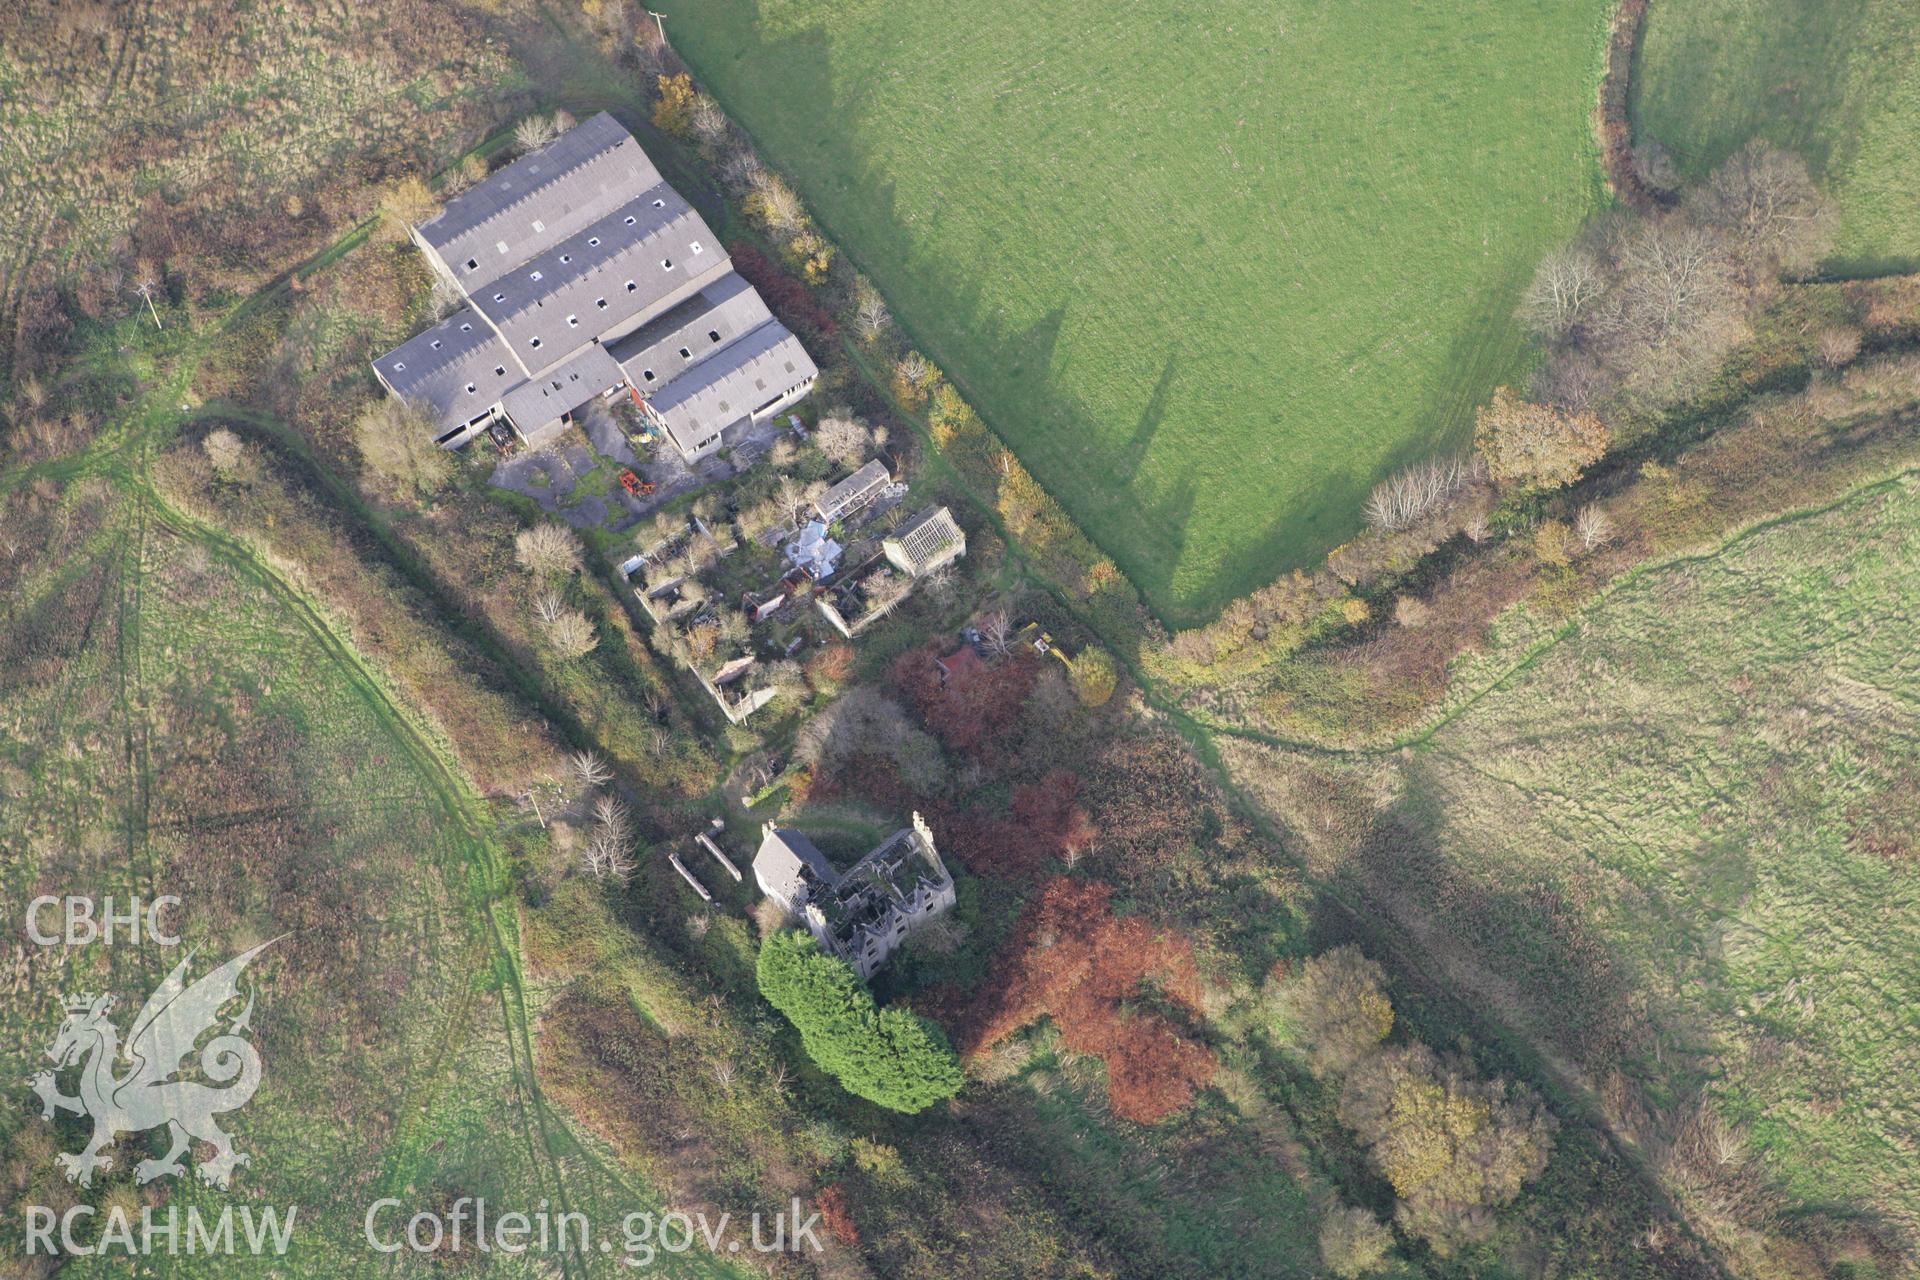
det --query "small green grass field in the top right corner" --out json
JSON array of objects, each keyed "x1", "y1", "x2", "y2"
[{"x1": 1630, "y1": 0, "x2": 1920, "y2": 274}]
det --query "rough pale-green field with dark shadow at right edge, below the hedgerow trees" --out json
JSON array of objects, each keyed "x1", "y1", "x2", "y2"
[{"x1": 1233, "y1": 472, "x2": 1920, "y2": 1274}]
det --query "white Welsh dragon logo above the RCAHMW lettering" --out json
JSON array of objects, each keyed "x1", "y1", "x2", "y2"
[{"x1": 29, "y1": 938, "x2": 278, "y2": 1188}]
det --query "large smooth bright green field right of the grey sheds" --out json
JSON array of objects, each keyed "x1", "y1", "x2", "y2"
[{"x1": 666, "y1": 0, "x2": 1609, "y2": 624}]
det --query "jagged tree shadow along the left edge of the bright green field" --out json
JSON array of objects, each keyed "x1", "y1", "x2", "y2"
[{"x1": 662, "y1": 0, "x2": 1328, "y2": 626}]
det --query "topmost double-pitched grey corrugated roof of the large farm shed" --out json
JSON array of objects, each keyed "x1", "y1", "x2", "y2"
[{"x1": 417, "y1": 111, "x2": 660, "y2": 290}]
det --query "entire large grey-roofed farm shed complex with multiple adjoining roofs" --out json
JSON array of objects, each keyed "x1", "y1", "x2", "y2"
[{"x1": 372, "y1": 113, "x2": 820, "y2": 462}]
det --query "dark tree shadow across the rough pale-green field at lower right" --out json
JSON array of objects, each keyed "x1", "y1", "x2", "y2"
[{"x1": 1308, "y1": 802, "x2": 1758, "y2": 1278}]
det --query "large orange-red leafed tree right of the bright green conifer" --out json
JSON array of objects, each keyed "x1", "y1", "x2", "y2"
[{"x1": 958, "y1": 877, "x2": 1215, "y2": 1125}]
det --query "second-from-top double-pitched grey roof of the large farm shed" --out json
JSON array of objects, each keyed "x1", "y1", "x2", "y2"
[{"x1": 470, "y1": 184, "x2": 732, "y2": 372}]
